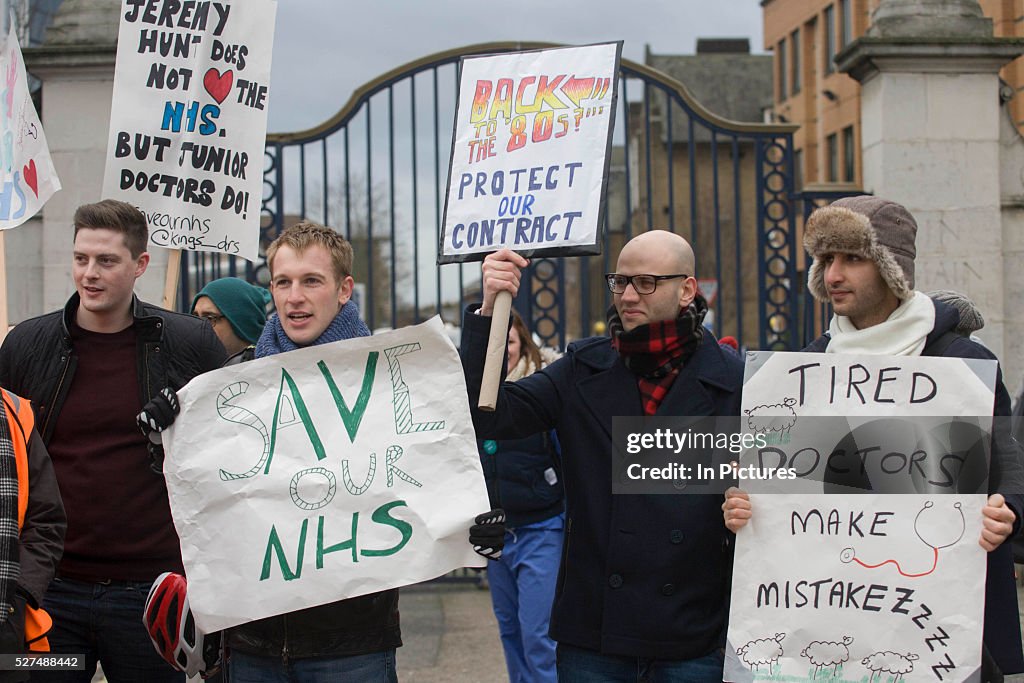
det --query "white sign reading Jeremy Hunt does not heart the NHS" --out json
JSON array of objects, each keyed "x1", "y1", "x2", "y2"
[{"x1": 103, "y1": 0, "x2": 276, "y2": 260}]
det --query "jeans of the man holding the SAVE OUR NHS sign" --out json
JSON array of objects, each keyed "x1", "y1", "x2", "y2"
[{"x1": 227, "y1": 649, "x2": 398, "y2": 683}]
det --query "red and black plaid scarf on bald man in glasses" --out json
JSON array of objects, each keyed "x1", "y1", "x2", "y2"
[{"x1": 608, "y1": 294, "x2": 708, "y2": 415}]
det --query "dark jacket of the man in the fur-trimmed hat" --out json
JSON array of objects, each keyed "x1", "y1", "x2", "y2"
[{"x1": 804, "y1": 301, "x2": 1024, "y2": 674}]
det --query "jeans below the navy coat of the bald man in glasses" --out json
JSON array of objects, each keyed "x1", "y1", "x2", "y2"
[{"x1": 558, "y1": 643, "x2": 724, "y2": 683}]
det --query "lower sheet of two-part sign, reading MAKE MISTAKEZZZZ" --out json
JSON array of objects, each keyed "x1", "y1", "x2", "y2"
[{"x1": 725, "y1": 495, "x2": 985, "y2": 681}]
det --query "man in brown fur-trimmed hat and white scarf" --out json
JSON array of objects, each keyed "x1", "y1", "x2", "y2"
[{"x1": 723, "y1": 196, "x2": 1024, "y2": 680}]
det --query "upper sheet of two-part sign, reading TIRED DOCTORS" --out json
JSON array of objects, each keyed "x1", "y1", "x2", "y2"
[{"x1": 740, "y1": 351, "x2": 996, "y2": 494}]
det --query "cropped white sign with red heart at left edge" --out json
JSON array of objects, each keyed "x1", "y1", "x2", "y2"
[{"x1": 0, "y1": 22, "x2": 60, "y2": 229}]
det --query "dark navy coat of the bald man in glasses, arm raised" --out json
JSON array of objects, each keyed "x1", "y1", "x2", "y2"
[{"x1": 462, "y1": 313, "x2": 743, "y2": 659}]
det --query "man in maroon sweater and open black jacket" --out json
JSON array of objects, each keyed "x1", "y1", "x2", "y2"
[{"x1": 0, "y1": 200, "x2": 226, "y2": 683}]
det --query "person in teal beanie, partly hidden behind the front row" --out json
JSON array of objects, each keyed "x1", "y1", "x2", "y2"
[{"x1": 193, "y1": 278, "x2": 270, "y2": 366}]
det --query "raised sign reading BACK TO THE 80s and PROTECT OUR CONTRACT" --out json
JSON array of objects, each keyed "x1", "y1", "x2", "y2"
[{"x1": 437, "y1": 42, "x2": 622, "y2": 263}]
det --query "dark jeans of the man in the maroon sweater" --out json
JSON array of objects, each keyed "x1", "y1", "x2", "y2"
[{"x1": 32, "y1": 579, "x2": 185, "y2": 683}]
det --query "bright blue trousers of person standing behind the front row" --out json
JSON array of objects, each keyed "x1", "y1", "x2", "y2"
[{"x1": 487, "y1": 515, "x2": 562, "y2": 683}]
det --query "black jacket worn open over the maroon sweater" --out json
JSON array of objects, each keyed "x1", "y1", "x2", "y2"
[{"x1": 0, "y1": 293, "x2": 227, "y2": 443}]
